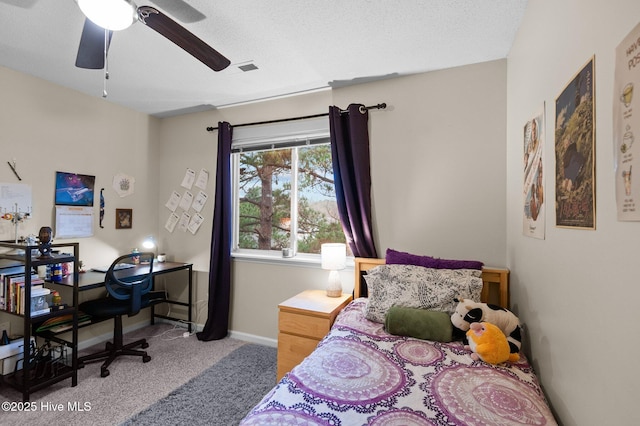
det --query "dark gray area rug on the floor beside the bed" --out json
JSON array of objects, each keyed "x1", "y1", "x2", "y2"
[{"x1": 123, "y1": 344, "x2": 276, "y2": 426}]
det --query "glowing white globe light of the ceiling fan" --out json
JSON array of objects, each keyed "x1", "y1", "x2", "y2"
[{"x1": 76, "y1": 0, "x2": 137, "y2": 31}]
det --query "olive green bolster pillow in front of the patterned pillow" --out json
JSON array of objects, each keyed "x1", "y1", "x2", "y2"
[{"x1": 384, "y1": 306, "x2": 453, "y2": 342}]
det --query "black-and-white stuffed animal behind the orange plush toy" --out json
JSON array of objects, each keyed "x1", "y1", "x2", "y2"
[{"x1": 451, "y1": 298, "x2": 522, "y2": 354}]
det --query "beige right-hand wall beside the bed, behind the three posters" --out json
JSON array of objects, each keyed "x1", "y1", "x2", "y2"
[{"x1": 507, "y1": 0, "x2": 640, "y2": 426}]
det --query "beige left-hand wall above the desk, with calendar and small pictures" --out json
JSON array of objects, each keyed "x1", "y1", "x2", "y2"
[{"x1": 0, "y1": 67, "x2": 159, "y2": 338}]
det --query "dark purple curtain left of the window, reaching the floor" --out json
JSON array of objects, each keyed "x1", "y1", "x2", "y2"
[{"x1": 196, "y1": 122, "x2": 232, "y2": 341}]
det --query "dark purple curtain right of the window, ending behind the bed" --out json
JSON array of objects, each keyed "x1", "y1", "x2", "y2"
[{"x1": 329, "y1": 104, "x2": 378, "y2": 257}]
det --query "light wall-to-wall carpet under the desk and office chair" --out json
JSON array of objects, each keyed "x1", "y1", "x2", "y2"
[{"x1": 0, "y1": 324, "x2": 276, "y2": 426}]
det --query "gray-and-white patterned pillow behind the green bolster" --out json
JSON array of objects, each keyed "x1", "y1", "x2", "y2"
[{"x1": 364, "y1": 265, "x2": 482, "y2": 323}]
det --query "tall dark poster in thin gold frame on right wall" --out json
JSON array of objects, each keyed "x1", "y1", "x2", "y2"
[{"x1": 555, "y1": 57, "x2": 596, "y2": 230}]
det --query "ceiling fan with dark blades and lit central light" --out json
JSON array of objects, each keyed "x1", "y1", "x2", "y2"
[{"x1": 76, "y1": 0, "x2": 231, "y2": 72}]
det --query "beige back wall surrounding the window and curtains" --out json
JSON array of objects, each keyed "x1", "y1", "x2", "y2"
[{"x1": 158, "y1": 61, "x2": 506, "y2": 341}]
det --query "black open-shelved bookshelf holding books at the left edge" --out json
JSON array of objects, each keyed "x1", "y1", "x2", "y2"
[{"x1": 0, "y1": 242, "x2": 80, "y2": 402}]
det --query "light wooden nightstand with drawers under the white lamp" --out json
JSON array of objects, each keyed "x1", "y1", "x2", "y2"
[{"x1": 277, "y1": 290, "x2": 351, "y2": 380}]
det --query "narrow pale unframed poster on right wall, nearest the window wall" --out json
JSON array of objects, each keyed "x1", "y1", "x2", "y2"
[{"x1": 522, "y1": 107, "x2": 546, "y2": 240}]
